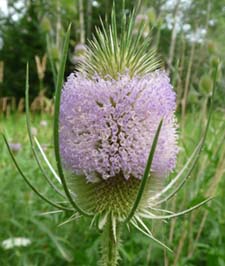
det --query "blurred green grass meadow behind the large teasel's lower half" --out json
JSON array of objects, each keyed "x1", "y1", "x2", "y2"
[{"x1": 0, "y1": 111, "x2": 225, "y2": 266}]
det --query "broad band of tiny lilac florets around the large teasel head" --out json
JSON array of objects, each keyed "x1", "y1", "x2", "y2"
[{"x1": 60, "y1": 71, "x2": 178, "y2": 181}]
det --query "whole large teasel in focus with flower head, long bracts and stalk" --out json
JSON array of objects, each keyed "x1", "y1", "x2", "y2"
[{"x1": 3, "y1": 4, "x2": 217, "y2": 266}]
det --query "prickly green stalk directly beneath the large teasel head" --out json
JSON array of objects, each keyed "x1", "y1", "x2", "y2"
[{"x1": 99, "y1": 217, "x2": 120, "y2": 266}]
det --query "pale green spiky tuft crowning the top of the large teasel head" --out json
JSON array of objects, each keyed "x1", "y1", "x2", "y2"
[{"x1": 78, "y1": 8, "x2": 161, "y2": 79}]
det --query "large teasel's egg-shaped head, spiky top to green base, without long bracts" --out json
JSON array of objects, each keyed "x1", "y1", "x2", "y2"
[{"x1": 59, "y1": 11, "x2": 178, "y2": 227}]
